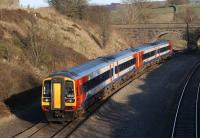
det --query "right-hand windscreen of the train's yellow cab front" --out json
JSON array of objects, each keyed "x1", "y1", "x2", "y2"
[{"x1": 65, "y1": 81, "x2": 74, "y2": 98}]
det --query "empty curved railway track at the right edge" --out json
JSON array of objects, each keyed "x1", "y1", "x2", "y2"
[{"x1": 171, "y1": 63, "x2": 200, "y2": 138}]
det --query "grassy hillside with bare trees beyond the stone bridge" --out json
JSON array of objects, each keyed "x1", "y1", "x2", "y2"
[{"x1": 111, "y1": 3, "x2": 200, "y2": 24}]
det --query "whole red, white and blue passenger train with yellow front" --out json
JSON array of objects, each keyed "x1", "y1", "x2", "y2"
[{"x1": 41, "y1": 40, "x2": 173, "y2": 121}]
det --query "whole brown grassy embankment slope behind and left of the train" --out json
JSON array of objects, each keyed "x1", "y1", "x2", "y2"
[{"x1": 0, "y1": 9, "x2": 127, "y2": 115}]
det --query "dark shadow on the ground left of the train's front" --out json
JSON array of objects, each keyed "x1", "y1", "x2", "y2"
[{"x1": 4, "y1": 86, "x2": 44, "y2": 123}]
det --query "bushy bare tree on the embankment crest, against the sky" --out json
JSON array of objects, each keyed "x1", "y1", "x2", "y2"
[{"x1": 48, "y1": 0, "x2": 88, "y2": 19}]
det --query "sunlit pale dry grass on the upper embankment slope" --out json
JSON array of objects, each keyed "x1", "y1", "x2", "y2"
[{"x1": 36, "y1": 9, "x2": 127, "y2": 59}]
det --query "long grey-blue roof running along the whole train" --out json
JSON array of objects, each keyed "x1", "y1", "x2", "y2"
[{"x1": 50, "y1": 41, "x2": 169, "y2": 80}]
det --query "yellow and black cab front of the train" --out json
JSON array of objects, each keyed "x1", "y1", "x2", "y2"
[{"x1": 41, "y1": 76, "x2": 76, "y2": 122}]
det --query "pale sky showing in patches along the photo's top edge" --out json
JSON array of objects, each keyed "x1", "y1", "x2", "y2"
[{"x1": 20, "y1": 0, "x2": 166, "y2": 8}]
